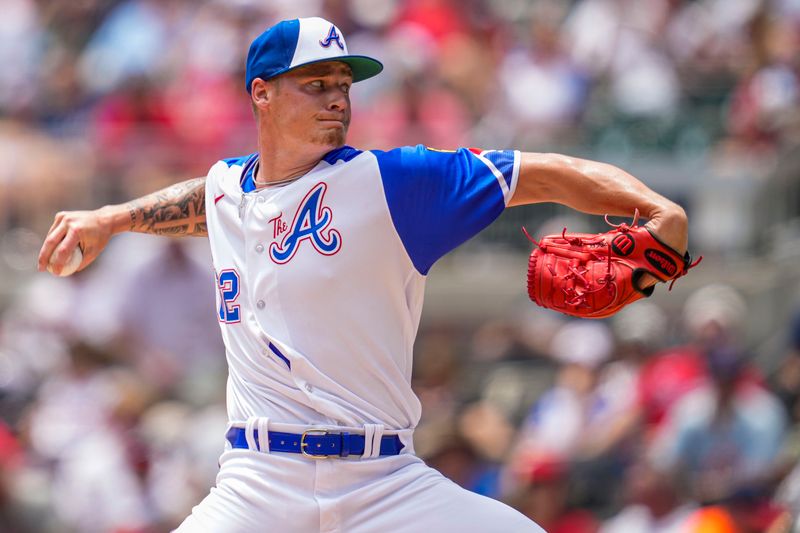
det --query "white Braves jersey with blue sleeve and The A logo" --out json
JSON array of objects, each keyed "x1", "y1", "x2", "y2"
[{"x1": 206, "y1": 146, "x2": 520, "y2": 429}]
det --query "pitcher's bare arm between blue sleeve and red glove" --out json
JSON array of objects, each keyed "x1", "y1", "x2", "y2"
[{"x1": 508, "y1": 153, "x2": 688, "y2": 254}]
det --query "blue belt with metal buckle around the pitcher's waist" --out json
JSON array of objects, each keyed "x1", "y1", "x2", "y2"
[{"x1": 225, "y1": 428, "x2": 403, "y2": 459}]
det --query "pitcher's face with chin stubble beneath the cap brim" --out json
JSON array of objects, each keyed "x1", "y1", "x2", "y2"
[{"x1": 267, "y1": 61, "x2": 353, "y2": 151}]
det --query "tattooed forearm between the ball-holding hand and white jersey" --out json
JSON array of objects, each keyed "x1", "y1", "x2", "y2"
[{"x1": 127, "y1": 178, "x2": 208, "y2": 236}]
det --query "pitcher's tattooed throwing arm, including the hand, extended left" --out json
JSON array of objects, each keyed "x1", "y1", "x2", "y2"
[{"x1": 39, "y1": 178, "x2": 208, "y2": 272}]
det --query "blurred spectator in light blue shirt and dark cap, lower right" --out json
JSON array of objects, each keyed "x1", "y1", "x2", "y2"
[{"x1": 651, "y1": 347, "x2": 786, "y2": 503}]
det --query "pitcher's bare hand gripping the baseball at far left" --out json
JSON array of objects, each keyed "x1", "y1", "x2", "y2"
[{"x1": 38, "y1": 208, "x2": 119, "y2": 273}]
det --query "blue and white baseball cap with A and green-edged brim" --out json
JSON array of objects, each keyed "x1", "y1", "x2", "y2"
[{"x1": 245, "y1": 17, "x2": 383, "y2": 94}]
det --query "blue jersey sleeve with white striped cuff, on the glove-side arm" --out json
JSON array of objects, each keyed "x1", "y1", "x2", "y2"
[{"x1": 373, "y1": 145, "x2": 520, "y2": 274}]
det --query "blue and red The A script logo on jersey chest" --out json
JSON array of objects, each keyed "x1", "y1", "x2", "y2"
[{"x1": 269, "y1": 182, "x2": 342, "y2": 265}]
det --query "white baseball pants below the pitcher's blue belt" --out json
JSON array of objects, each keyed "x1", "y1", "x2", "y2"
[{"x1": 176, "y1": 422, "x2": 544, "y2": 533}]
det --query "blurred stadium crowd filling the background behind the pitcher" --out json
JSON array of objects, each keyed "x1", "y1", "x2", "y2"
[{"x1": 0, "y1": 0, "x2": 800, "y2": 533}]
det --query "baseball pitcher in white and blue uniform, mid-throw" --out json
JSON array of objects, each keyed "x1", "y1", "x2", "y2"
[{"x1": 39, "y1": 18, "x2": 688, "y2": 533}]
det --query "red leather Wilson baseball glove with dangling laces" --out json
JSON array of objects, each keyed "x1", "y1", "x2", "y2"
[{"x1": 523, "y1": 211, "x2": 702, "y2": 318}]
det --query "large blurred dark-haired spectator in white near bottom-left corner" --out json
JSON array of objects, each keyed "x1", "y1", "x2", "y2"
[{"x1": 24, "y1": 343, "x2": 151, "y2": 533}]
